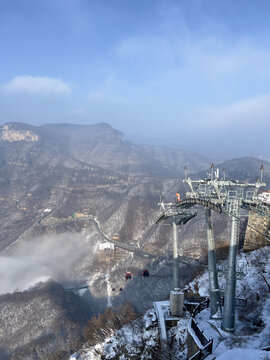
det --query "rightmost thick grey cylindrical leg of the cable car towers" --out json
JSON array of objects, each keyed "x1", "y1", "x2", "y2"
[{"x1": 221, "y1": 200, "x2": 239, "y2": 332}]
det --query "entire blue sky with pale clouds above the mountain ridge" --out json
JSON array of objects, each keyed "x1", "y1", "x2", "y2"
[{"x1": 0, "y1": 0, "x2": 270, "y2": 160}]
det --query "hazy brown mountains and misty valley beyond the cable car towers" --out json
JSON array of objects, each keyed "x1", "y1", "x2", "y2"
[{"x1": 0, "y1": 123, "x2": 270, "y2": 360}]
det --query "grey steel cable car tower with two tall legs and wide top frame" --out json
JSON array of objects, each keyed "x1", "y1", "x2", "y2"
[{"x1": 177, "y1": 164, "x2": 270, "y2": 332}]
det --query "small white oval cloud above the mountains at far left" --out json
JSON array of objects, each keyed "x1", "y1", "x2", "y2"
[{"x1": 3, "y1": 75, "x2": 71, "y2": 94}]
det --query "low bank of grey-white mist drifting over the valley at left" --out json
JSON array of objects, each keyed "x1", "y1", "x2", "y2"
[{"x1": 0, "y1": 234, "x2": 93, "y2": 294}]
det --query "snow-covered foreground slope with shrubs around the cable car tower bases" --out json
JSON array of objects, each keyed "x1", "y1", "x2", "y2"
[{"x1": 70, "y1": 247, "x2": 270, "y2": 360}]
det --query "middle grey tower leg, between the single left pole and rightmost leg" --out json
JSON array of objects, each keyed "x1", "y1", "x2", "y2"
[{"x1": 205, "y1": 207, "x2": 221, "y2": 319}]
